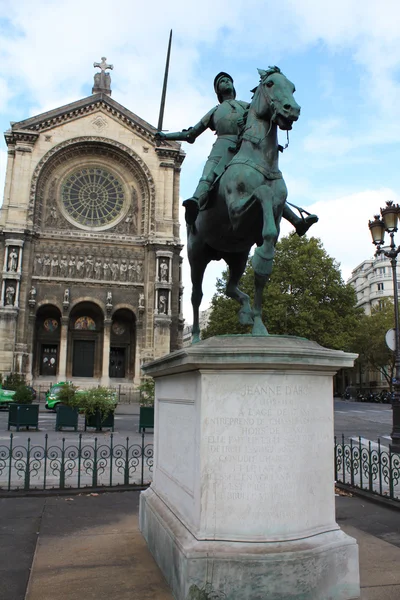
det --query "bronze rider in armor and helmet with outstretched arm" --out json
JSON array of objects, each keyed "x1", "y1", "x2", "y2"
[{"x1": 156, "y1": 72, "x2": 318, "y2": 231}]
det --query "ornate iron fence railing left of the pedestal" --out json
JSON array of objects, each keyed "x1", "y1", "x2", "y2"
[{"x1": 0, "y1": 433, "x2": 153, "y2": 491}]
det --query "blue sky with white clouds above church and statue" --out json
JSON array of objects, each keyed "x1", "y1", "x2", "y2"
[{"x1": 0, "y1": 0, "x2": 400, "y2": 323}]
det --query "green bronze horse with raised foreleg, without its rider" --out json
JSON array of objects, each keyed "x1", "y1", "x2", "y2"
[{"x1": 187, "y1": 67, "x2": 300, "y2": 343}]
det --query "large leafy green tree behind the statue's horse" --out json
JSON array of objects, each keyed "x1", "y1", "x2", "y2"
[{"x1": 203, "y1": 233, "x2": 362, "y2": 350}]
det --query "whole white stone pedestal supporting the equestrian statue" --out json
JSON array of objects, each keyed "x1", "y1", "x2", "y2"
[{"x1": 140, "y1": 336, "x2": 359, "y2": 600}]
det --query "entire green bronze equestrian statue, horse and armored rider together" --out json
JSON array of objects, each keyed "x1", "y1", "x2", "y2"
[{"x1": 157, "y1": 67, "x2": 318, "y2": 342}]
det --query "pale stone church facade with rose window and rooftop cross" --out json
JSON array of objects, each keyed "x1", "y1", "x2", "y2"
[{"x1": 0, "y1": 60, "x2": 184, "y2": 385}]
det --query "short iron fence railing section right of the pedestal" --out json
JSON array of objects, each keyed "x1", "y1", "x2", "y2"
[{"x1": 335, "y1": 436, "x2": 400, "y2": 501}]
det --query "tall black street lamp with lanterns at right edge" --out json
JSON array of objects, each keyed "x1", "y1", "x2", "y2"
[{"x1": 368, "y1": 201, "x2": 400, "y2": 452}]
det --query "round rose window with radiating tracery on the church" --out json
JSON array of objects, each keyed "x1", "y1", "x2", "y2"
[{"x1": 61, "y1": 167, "x2": 125, "y2": 227}]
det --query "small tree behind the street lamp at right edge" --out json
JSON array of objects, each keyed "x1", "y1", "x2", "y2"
[{"x1": 353, "y1": 298, "x2": 395, "y2": 391}]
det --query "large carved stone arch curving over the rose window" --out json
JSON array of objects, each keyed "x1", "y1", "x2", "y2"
[{"x1": 28, "y1": 136, "x2": 155, "y2": 235}]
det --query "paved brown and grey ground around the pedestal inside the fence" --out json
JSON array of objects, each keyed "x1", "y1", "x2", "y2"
[{"x1": 0, "y1": 491, "x2": 400, "y2": 600}]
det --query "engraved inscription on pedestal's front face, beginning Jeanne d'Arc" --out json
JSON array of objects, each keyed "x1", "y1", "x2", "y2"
[{"x1": 203, "y1": 375, "x2": 333, "y2": 535}]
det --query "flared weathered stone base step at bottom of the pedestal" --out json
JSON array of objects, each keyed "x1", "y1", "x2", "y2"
[{"x1": 139, "y1": 488, "x2": 360, "y2": 600}]
